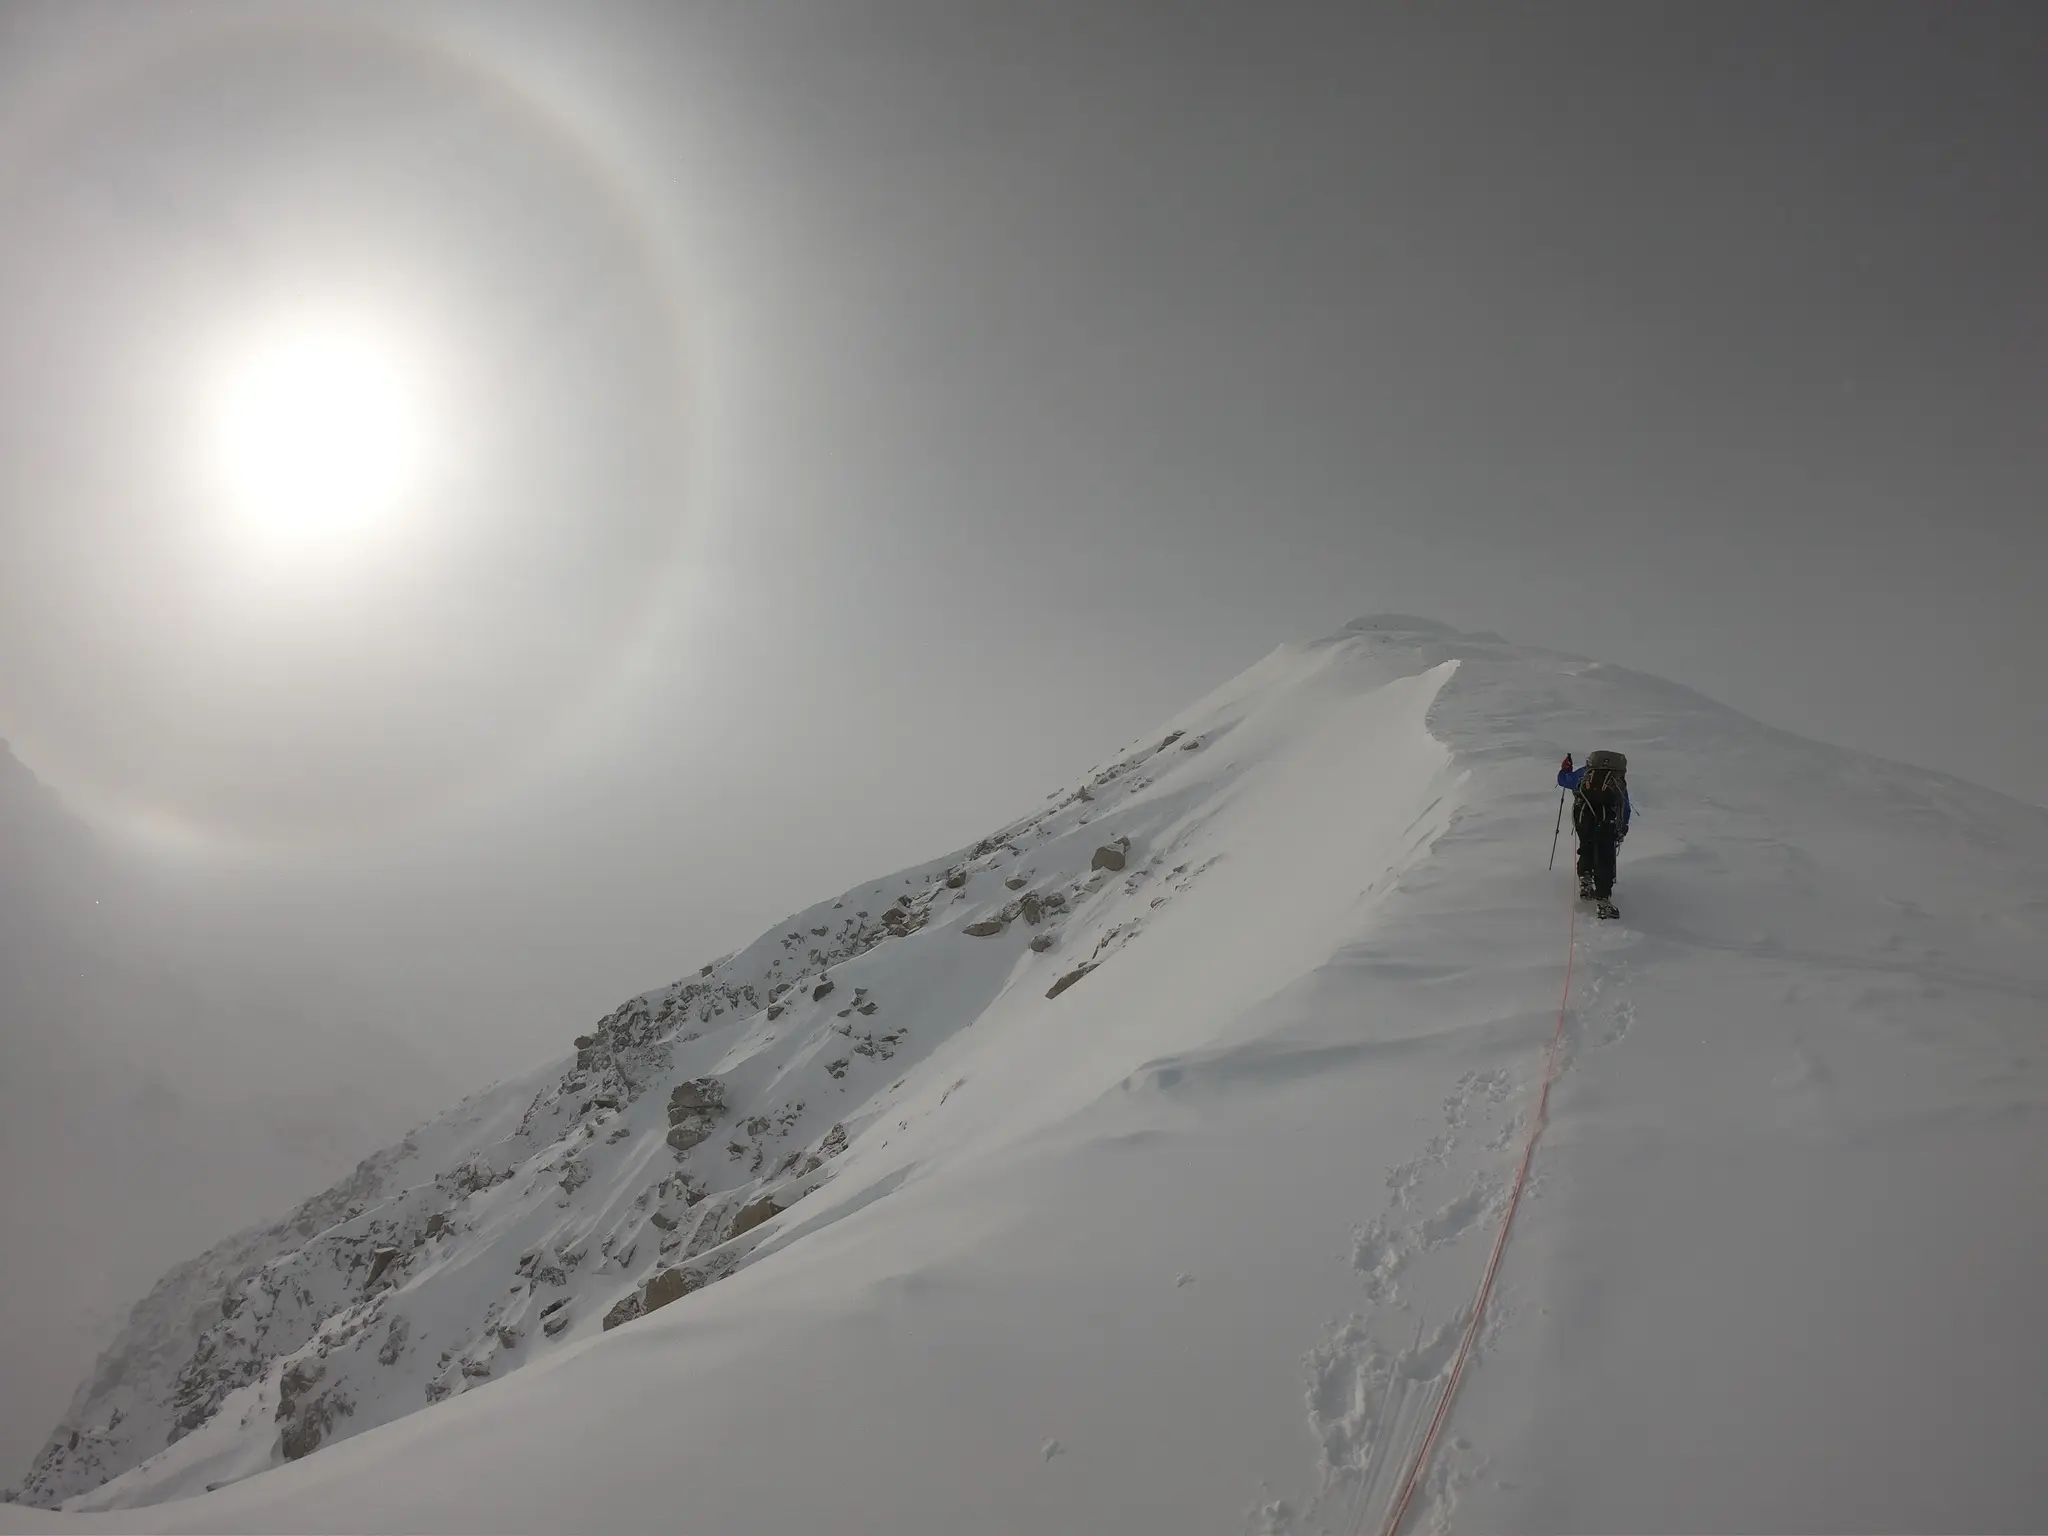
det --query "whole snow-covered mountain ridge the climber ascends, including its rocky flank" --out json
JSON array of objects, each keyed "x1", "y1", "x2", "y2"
[{"x1": 0, "y1": 618, "x2": 2048, "y2": 1536}]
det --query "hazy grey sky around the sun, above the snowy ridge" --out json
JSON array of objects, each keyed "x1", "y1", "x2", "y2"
[{"x1": 0, "y1": 0, "x2": 2048, "y2": 1482}]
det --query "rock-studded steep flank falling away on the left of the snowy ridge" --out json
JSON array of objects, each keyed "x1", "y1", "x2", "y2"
[{"x1": 20, "y1": 618, "x2": 1400, "y2": 1507}]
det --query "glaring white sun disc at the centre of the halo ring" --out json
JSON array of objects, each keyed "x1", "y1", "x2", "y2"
[{"x1": 213, "y1": 324, "x2": 424, "y2": 543}]
